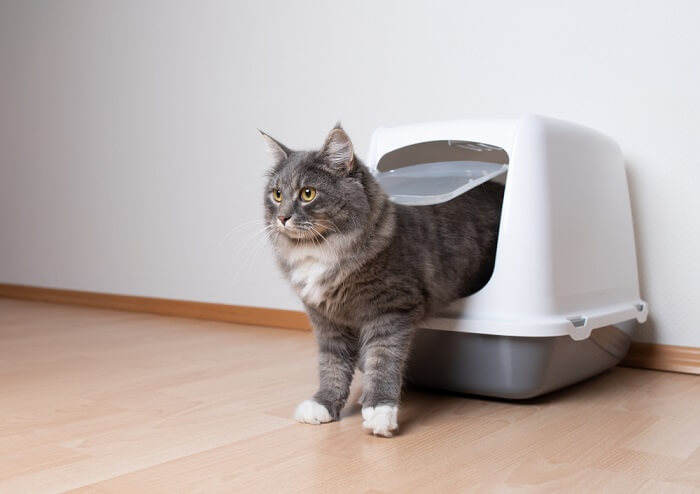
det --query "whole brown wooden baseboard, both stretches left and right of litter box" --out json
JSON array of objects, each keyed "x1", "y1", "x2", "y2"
[{"x1": 0, "y1": 283, "x2": 700, "y2": 374}]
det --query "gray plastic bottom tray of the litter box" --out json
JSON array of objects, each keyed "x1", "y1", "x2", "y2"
[{"x1": 408, "y1": 320, "x2": 637, "y2": 399}]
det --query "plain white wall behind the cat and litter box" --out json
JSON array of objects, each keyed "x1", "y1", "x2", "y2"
[{"x1": 0, "y1": 0, "x2": 700, "y2": 346}]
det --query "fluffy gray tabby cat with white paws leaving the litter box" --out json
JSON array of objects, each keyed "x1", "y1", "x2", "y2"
[{"x1": 261, "y1": 125, "x2": 503, "y2": 437}]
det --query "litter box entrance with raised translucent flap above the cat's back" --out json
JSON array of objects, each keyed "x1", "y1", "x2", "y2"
[{"x1": 376, "y1": 140, "x2": 508, "y2": 206}]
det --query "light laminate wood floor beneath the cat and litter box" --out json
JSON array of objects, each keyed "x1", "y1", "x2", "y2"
[{"x1": 0, "y1": 299, "x2": 700, "y2": 493}]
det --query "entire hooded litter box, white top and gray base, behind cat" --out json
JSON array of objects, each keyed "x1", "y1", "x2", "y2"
[{"x1": 367, "y1": 115, "x2": 648, "y2": 398}]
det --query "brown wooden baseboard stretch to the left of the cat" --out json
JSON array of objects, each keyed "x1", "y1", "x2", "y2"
[{"x1": 0, "y1": 283, "x2": 311, "y2": 330}]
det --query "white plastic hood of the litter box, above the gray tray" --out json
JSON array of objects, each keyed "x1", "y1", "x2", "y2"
[{"x1": 367, "y1": 115, "x2": 648, "y2": 340}]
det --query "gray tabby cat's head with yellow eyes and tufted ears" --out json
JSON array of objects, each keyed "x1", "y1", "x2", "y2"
[{"x1": 261, "y1": 125, "x2": 371, "y2": 243}]
